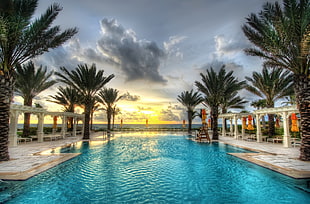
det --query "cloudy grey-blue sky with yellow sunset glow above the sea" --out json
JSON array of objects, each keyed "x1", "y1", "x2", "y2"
[{"x1": 15, "y1": 0, "x2": 280, "y2": 123}]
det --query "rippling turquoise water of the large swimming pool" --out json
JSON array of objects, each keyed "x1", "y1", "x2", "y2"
[{"x1": 0, "y1": 133, "x2": 310, "y2": 204}]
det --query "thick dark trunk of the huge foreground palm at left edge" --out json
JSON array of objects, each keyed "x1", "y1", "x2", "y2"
[{"x1": 0, "y1": 73, "x2": 14, "y2": 161}]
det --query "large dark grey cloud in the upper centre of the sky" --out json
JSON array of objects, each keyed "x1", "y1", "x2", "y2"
[{"x1": 98, "y1": 19, "x2": 166, "y2": 83}]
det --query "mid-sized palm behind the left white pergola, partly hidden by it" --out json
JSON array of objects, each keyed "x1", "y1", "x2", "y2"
[{"x1": 15, "y1": 61, "x2": 57, "y2": 137}]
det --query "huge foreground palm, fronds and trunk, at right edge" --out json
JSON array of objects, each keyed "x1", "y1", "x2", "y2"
[{"x1": 243, "y1": 0, "x2": 310, "y2": 161}]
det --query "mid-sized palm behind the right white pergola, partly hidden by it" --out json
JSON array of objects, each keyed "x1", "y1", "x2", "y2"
[{"x1": 245, "y1": 68, "x2": 294, "y2": 137}]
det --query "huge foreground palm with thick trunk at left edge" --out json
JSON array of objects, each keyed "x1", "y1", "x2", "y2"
[{"x1": 0, "y1": 0, "x2": 77, "y2": 161}]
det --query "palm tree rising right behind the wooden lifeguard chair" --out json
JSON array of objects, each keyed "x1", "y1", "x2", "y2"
[{"x1": 195, "y1": 65, "x2": 245, "y2": 140}]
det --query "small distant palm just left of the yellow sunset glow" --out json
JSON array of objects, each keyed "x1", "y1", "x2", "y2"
[{"x1": 98, "y1": 88, "x2": 122, "y2": 131}]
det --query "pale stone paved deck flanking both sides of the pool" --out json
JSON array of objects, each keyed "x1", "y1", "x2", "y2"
[{"x1": 0, "y1": 132, "x2": 310, "y2": 180}]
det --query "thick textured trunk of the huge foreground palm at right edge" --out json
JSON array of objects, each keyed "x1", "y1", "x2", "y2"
[{"x1": 295, "y1": 75, "x2": 310, "y2": 161}]
